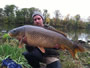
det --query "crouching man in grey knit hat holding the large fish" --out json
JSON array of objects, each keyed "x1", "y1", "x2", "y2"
[{"x1": 23, "y1": 11, "x2": 63, "y2": 68}]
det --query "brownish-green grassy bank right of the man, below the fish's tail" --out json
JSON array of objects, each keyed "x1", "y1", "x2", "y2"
[{"x1": 60, "y1": 51, "x2": 90, "y2": 68}]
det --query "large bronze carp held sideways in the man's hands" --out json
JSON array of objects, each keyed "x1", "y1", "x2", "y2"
[{"x1": 8, "y1": 25, "x2": 84, "y2": 58}]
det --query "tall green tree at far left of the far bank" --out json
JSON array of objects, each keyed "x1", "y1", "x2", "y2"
[{"x1": 4, "y1": 5, "x2": 17, "y2": 24}]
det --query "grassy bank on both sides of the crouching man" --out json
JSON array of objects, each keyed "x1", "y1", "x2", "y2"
[{"x1": 0, "y1": 41, "x2": 90, "y2": 68}]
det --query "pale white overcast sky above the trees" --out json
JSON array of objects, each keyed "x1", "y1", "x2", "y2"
[{"x1": 0, "y1": 0, "x2": 90, "y2": 19}]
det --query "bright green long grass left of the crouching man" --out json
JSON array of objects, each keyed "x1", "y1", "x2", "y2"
[{"x1": 0, "y1": 43, "x2": 31, "y2": 68}]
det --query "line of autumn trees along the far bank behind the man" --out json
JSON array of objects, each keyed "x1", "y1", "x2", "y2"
[{"x1": 0, "y1": 5, "x2": 90, "y2": 28}]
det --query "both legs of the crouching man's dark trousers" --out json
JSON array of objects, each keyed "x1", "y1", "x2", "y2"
[{"x1": 23, "y1": 49, "x2": 61, "y2": 68}]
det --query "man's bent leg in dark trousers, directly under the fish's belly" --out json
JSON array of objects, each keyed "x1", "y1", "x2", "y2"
[{"x1": 22, "y1": 49, "x2": 43, "y2": 68}]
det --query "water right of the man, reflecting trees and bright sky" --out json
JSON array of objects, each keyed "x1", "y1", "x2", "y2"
[{"x1": 58, "y1": 29, "x2": 90, "y2": 42}]
